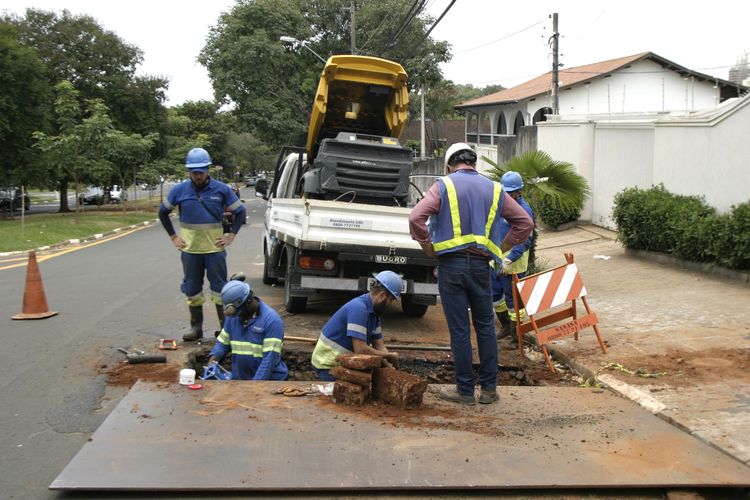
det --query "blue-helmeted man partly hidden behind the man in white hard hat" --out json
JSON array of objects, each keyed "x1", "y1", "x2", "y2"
[{"x1": 492, "y1": 171, "x2": 535, "y2": 347}]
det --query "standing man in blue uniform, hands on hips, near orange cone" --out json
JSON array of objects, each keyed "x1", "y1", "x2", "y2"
[{"x1": 159, "y1": 148, "x2": 245, "y2": 341}]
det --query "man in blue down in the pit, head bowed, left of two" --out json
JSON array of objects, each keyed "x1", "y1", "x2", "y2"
[{"x1": 208, "y1": 280, "x2": 289, "y2": 380}]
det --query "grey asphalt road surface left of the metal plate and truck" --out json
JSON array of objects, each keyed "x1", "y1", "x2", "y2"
[{"x1": 0, "y1": 189, "x2": 268, "y2": 499}]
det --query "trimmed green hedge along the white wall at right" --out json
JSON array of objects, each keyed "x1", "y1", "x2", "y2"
[{"x1": 613, "y1": 185, "x2": 750, "y2": 269}]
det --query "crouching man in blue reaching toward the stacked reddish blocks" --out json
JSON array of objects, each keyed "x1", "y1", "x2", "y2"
[{"x1": 312, "y1": 271, "x2": 401, "y2": 381}]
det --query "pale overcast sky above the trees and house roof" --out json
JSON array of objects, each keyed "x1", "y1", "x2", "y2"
[{"x1": 0, "y1": 0, "x2": 750, "y2": 104}]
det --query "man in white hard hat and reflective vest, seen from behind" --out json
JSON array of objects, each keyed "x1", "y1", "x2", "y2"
[{"x1": 409, "y1": 143, "x2": 534, "y2": 405}]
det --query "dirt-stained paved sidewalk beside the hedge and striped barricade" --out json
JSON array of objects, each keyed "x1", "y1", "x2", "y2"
[{"x1": 537, "y1": 226, "x2": 750, "y2": 465}]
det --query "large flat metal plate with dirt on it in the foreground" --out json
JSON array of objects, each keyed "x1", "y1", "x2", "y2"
[{"x1": 50, "y1": 381, "x2": 750, "y2": 492}]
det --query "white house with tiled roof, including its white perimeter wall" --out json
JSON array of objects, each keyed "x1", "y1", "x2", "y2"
[{"x1": 457, "y1": 52, "x2": 750, "y2": 228}]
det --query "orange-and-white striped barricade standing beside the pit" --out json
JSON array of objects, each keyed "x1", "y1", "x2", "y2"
[{"x1": 513, "y1": 253, "x2": 607, "y2": 371}]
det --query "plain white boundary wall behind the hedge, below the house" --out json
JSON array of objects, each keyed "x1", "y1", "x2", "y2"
[{"x1": 537, "y1": 95, "x2": 750, "y2": 228}]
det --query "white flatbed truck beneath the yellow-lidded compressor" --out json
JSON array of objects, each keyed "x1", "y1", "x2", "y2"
[{"x1": 258, "y1": 153, "x2": 438, "y2": 316}]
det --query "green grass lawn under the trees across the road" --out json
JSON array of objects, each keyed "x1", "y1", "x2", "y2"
[{"x1": 0, "y1": 210, "x2": 156, "y2": 252}]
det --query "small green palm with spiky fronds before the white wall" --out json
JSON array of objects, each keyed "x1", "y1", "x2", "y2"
[{"x1": 482, "y1": 151, "x2": 591, "y2": 274}]
